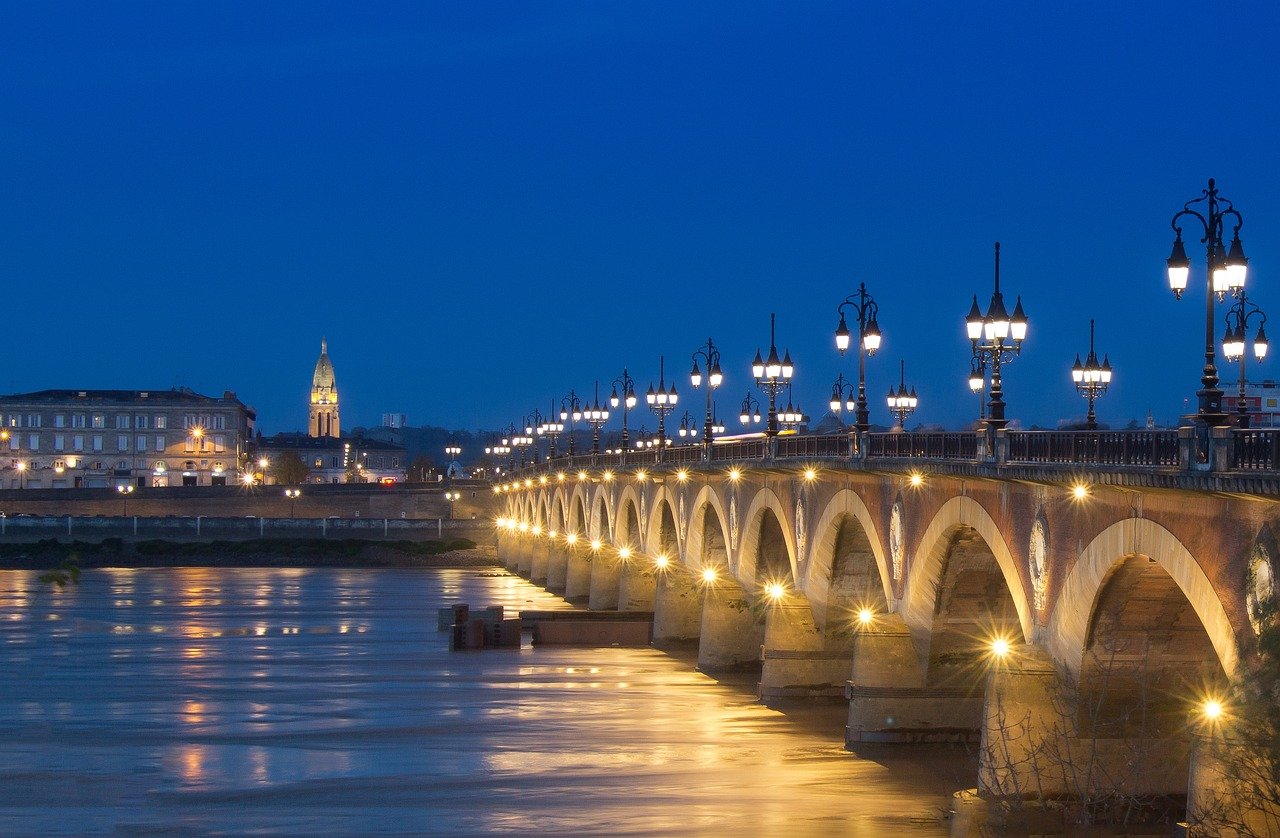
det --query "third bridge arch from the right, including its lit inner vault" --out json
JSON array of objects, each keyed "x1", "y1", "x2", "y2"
[{"x1": 804, "y1": 489, "x2": 893, "y2": 623}]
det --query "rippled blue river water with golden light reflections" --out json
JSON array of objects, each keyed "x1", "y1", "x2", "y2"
[{"x1": 0, "y1": 569, "x2": 974, "y2": 835}]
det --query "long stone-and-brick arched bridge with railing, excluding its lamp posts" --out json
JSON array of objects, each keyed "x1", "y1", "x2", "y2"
[{"x1": 494, "y1": 427, "x2": 1280, "y2": 829}]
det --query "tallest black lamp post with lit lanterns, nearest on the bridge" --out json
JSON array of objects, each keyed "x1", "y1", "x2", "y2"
[{"x1": 1166, "y1": 178, "x2": 1249, "y2": 426}]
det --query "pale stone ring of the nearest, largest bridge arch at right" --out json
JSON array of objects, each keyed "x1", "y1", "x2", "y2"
[{"x1": 1050, "y1": 518, "x2": 1239, "y2": 681}]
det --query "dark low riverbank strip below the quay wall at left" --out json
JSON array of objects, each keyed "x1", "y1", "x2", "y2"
[{"x1": 0, "y1": 539, "x2": 502, "y2": 571}]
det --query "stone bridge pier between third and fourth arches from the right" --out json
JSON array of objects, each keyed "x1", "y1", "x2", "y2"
[{"x1": 756, "y1": 597, "x2": 852, "y2": 700}]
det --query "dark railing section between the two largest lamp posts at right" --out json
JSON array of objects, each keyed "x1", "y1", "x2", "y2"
[{"x1": 1005, "y1": 430, "x2": 1179, "y2": 467}]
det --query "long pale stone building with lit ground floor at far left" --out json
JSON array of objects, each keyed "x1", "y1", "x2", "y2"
[{"x1": 0, "y1": 388, "x2": 256, "y2": 489}]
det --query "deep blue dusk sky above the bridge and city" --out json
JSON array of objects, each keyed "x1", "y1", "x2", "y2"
[{"x1": 0, "y1": 1, "x2": 1280, "y2": 432}]
